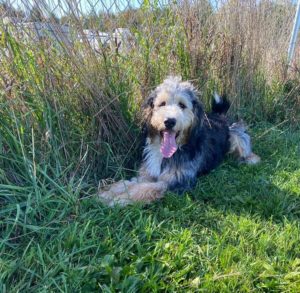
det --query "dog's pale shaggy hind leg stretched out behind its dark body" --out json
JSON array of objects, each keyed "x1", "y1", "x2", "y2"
[{"x1": 229, "y1": 122, "x2": 260, "y2": 165}]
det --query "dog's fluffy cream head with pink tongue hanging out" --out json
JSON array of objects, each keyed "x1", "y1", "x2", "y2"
[{"x1": 143, "y1": 77, "x2": 204, "y2": 158}]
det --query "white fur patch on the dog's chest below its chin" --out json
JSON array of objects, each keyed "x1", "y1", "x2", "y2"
[{"x1": 144, "y1": 137, "x2": 163, "y2": 178}]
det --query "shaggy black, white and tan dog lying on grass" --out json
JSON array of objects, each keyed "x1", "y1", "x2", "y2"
[{"x1": 99, "y1": 76, "x2": 260, "y2": 206}]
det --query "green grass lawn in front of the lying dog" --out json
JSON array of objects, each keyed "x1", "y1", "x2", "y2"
[{"x1": 0, "y1": 124, "x2": 300, "y2": 292}]
